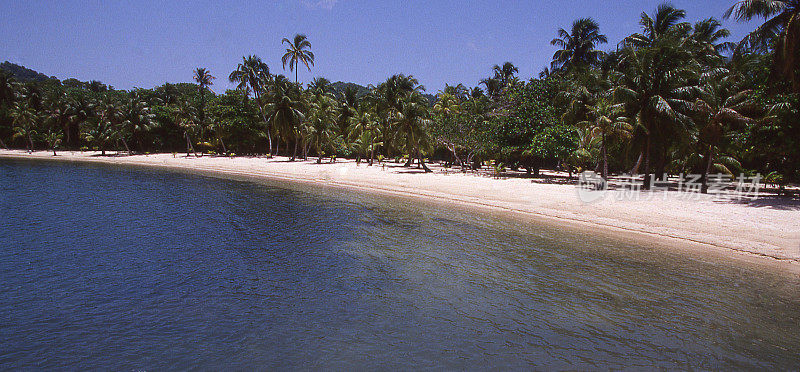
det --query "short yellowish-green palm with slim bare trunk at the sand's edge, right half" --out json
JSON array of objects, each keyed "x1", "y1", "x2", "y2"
[{"x1": 579, "y1": 98, "x2": 633, "y2": 180}]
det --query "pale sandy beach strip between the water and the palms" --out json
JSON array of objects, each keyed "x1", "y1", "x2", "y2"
[{"x1": 0, "y1": 150, "x2": 800, "y2": 271}]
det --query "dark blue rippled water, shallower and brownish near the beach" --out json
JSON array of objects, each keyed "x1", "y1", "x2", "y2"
[{"x1": 0, "y1": 160, "x2": 800, "y2": 370}]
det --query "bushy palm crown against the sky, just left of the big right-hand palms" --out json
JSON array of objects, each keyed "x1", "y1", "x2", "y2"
[{"x1": 546, "y1": 18, "x2": 608, "y2": 75}]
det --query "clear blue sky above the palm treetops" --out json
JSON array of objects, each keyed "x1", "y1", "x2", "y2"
[{"x1": 0, "y1": 0, "x2": 755, "y2": 93}]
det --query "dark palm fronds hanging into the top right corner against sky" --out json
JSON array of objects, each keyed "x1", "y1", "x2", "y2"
[{"x1": 725, "y1": 0, "x2": 800, "y2": 93}]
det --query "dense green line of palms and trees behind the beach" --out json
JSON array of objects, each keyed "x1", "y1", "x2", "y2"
[{"x1": 0, "y1": 0, "x2": 800, "y2": 189}]
